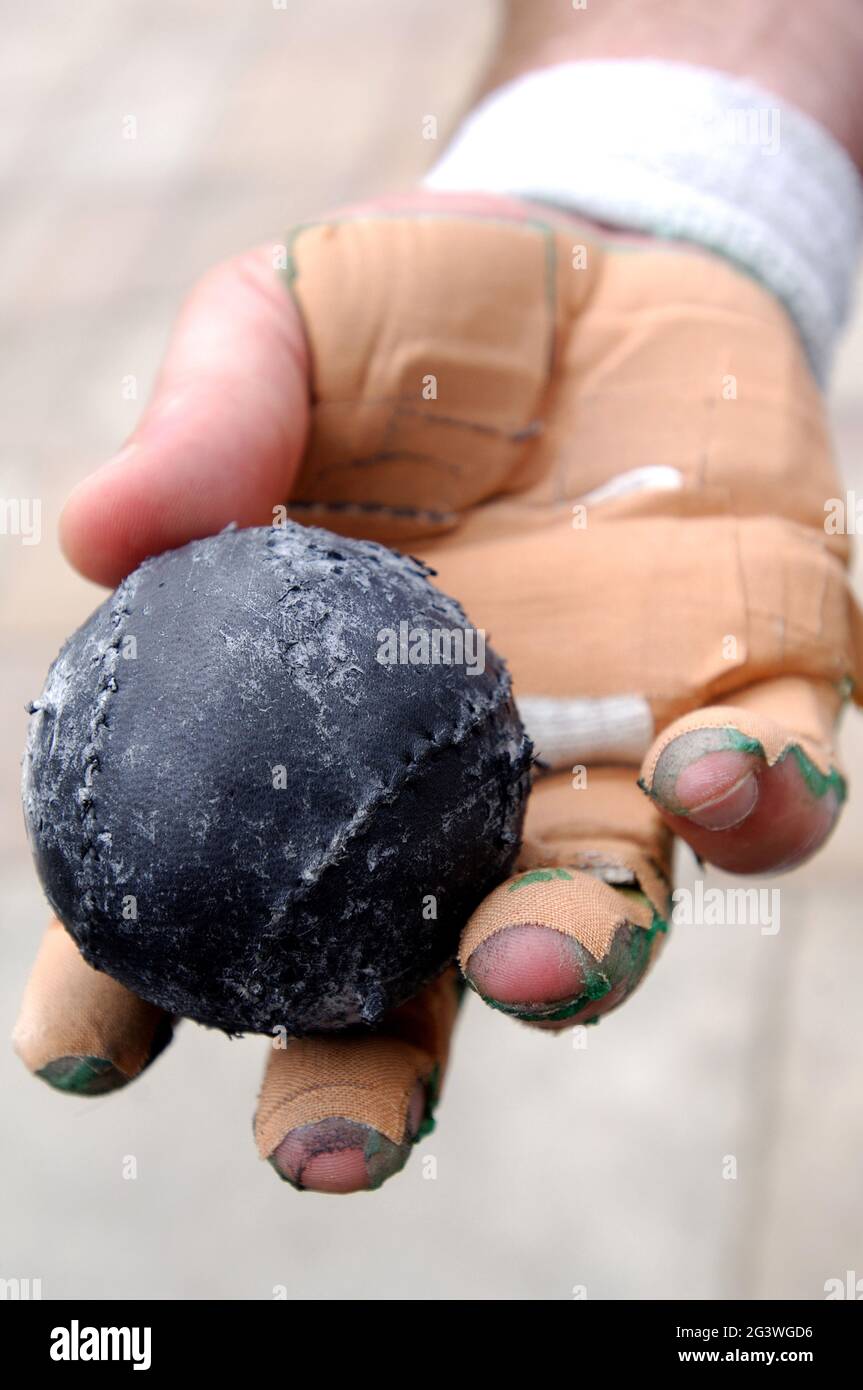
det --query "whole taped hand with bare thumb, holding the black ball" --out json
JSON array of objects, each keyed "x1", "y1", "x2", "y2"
[{"x1": 18, "y1": 195, "x2": 855, "y2": 1191}]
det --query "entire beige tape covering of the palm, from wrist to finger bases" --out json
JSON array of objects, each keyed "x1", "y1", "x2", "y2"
[{"x1": 284, "y1": 215, "x2": 863, "y2": 739}]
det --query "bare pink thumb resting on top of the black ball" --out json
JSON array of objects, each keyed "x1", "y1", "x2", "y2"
[{"x1": 60, "y1": 246, "x2": 309, "y2": 585}]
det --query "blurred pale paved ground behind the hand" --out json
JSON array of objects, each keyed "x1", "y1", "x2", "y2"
[{"x1": 0, "y1": 0, "x2": 863, "y2": 1300}]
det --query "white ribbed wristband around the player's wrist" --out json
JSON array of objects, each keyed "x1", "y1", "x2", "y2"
[{"x1": 425, "y1": 60, "x2": 863, "y2": 379}]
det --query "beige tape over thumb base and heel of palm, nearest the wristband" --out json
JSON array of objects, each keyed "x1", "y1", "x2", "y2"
[{"x1": 289, "y1": 215, "x2": 845, "y2": 536}]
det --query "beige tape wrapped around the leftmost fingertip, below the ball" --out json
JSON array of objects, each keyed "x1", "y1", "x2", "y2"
[{"x1": 13, "y1": 922, "x2": 165, "y2": 1079}]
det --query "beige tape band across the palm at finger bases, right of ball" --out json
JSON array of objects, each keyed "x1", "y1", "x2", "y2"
[{"x1": 421, "y1": 517, "x2": 859, "y2": 730}]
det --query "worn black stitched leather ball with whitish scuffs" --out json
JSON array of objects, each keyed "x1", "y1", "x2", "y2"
[{"x1": 24, "y1": 524, "x2": 531, "y2": 1034}]
